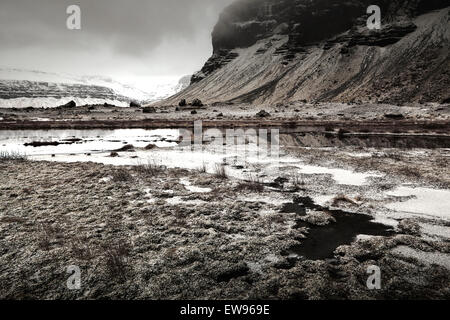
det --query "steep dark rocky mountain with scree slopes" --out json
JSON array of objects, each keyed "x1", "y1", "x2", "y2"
[{"x1": 164, "y1": 0, "x2": 450, "y2": 104}]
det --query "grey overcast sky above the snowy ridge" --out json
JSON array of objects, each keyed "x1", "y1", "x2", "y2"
[{"x1": 0, "y1": 0, "x2": 233, "y2": 77}]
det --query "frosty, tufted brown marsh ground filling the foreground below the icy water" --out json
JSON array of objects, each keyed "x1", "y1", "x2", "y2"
[{"x1": 0, "y1": 148, "x2": 450, "y2": 299}]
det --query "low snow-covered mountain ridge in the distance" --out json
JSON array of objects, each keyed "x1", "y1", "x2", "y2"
[{"x1": 0, "y1": 69, "x2": 188, "y2": 108}]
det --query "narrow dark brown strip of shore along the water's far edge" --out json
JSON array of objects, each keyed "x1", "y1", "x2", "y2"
[{"x1": 0, "y1": 119, "x2": 450, "y2": 136}]
